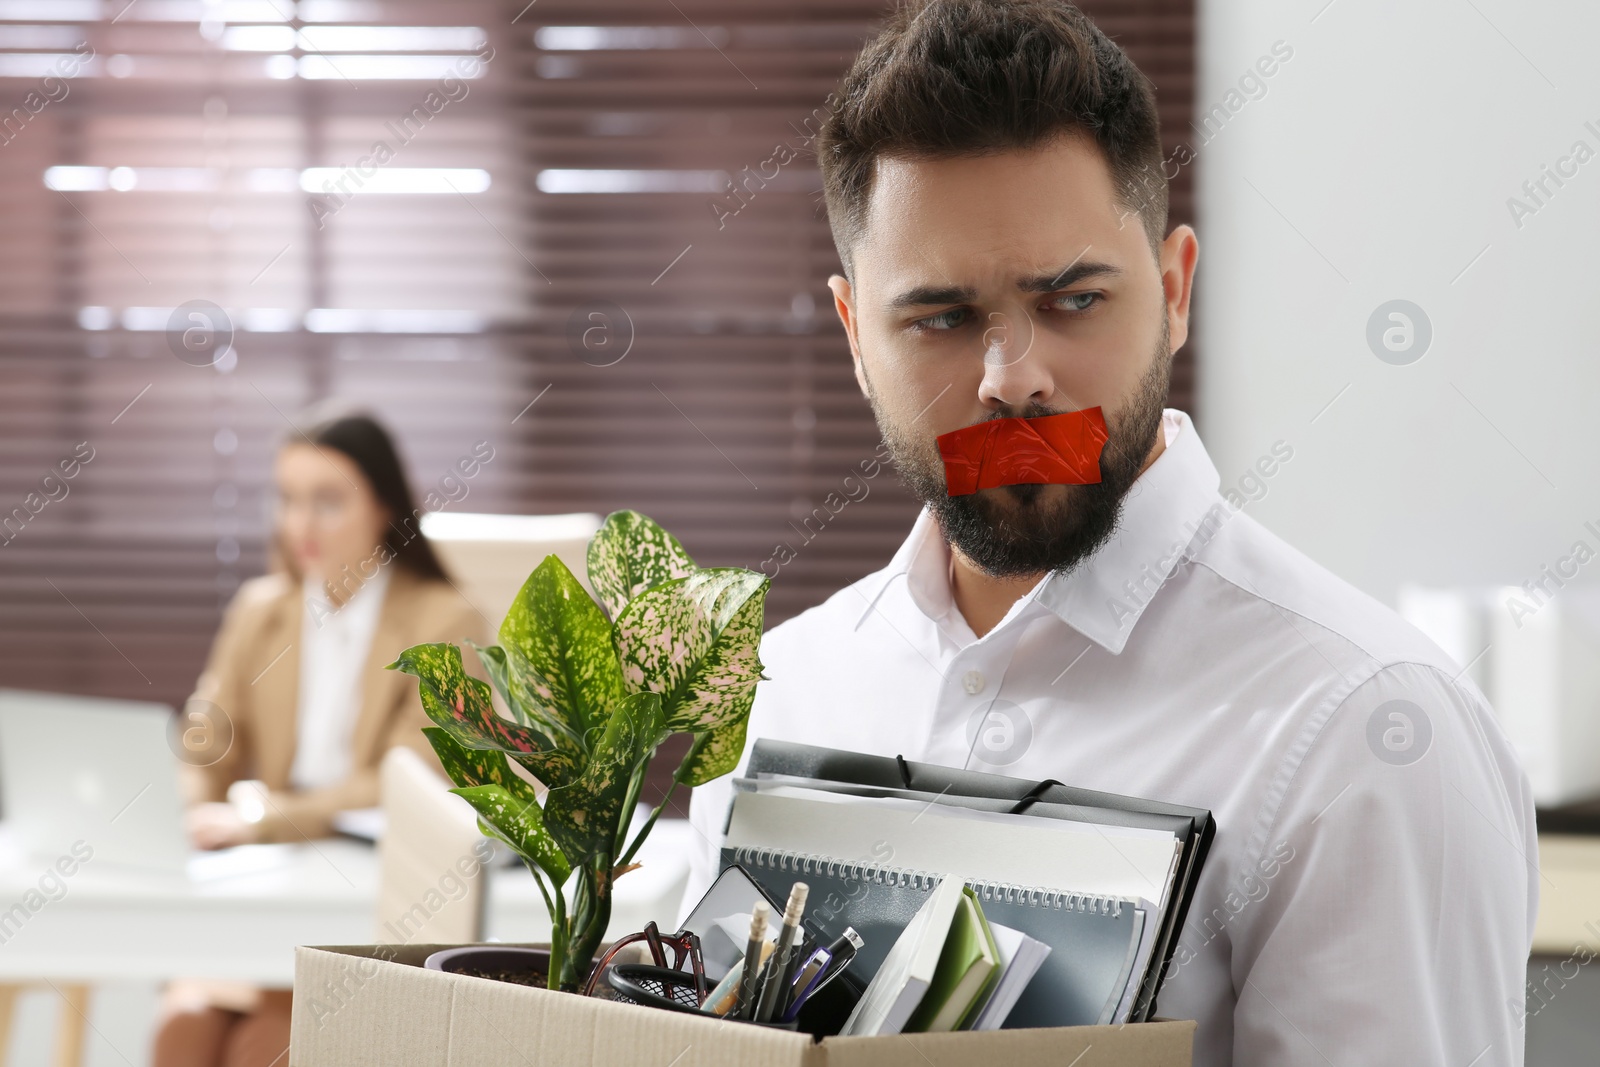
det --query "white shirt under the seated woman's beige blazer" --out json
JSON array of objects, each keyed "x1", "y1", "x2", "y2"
[{"x1": 290, "y1": 568, "x2": 389, "y2": 789}]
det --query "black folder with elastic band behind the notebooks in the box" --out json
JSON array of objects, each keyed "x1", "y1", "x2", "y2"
[{"x1": 746, "y1": 739, "x2": 1216, "y2": 1022}]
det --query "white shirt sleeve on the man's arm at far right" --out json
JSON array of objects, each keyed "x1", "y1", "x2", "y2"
[{"x1": 1232, "y1": 664, "x2": 1538, "y2": 1067}]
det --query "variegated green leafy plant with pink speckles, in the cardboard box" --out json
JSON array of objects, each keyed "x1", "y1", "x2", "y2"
[{"x1": 390, "y1": 512, "x2": 770, "y2": 990}]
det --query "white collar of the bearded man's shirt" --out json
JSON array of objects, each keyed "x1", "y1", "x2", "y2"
[{"x1": 856, "y1": 410, "x2": 1221, "y2": 654}]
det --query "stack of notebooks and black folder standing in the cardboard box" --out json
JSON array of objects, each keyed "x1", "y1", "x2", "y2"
[{"x1": 722, "y1": 741, "x2": 1213, "y2": 1033}]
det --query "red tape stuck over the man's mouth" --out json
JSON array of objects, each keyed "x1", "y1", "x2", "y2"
[{"x1": 938, "y1": 408, "x2": 1109, "y2": 496}]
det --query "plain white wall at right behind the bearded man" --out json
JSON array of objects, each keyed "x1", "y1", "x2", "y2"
[{"x1": 1189, "y1": 0, "x2": 1600, "y2": 603}]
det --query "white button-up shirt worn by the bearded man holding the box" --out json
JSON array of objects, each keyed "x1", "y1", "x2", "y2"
[{"x1": 685, "y1": 411, "x2": 1538, "y2": 1067}]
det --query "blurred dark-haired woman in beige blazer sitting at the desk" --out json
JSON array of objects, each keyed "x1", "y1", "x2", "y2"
[{"x1": 152, "y1": 414, "x2": 486, "y2": 1067}]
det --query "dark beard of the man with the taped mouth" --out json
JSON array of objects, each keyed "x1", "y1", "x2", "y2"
[{"x1": 869, "y1": 315, "x2": 1171, "y2": 577}]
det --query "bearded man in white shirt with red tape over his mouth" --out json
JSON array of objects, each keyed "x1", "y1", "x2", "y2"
[{"x1": 690, "y1": 0, "x2": 1538, "y2": 1067}]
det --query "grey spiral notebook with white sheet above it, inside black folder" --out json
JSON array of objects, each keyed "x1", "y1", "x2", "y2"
[{"x1": 723, "y1": 781, "x2": 1176, "y2": 1027}]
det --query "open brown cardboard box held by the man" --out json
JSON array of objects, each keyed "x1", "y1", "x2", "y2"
[{"x1": 290, "y1": 945, "x2": 1195, "y2": 1067}]
